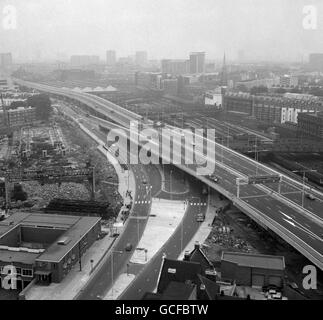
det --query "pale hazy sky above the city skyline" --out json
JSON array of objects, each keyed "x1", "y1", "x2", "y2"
[{"x1": 0, "y1": 0, "x2": 323, "y2": 61}]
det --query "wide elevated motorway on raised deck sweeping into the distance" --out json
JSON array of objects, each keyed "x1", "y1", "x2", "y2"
[{"x1": 17, "y1": 81, "x2": 323, "y2": 270}]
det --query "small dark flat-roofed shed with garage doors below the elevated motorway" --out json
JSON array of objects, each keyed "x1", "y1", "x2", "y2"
[{"x1": 221, "y1": 251, "x2": 285, "y2": 288}]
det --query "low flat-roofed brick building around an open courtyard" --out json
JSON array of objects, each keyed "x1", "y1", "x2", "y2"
[{"x1": 0, "y1": 213, "x2": 101, "y2": 289}]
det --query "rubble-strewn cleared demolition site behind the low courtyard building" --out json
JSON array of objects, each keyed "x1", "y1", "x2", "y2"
[{"x1": 0, "y1": 89, "x2": 122, "y2": 226}]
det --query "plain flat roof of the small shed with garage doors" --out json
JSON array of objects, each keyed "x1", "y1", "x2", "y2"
[{"x1": 221, "y1": 251, "x2": 285, "y2": 270}]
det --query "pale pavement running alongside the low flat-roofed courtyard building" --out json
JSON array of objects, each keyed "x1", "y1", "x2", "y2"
[{"x1": 25, "y1": 235, "x2": 115, "y2": 300}]
